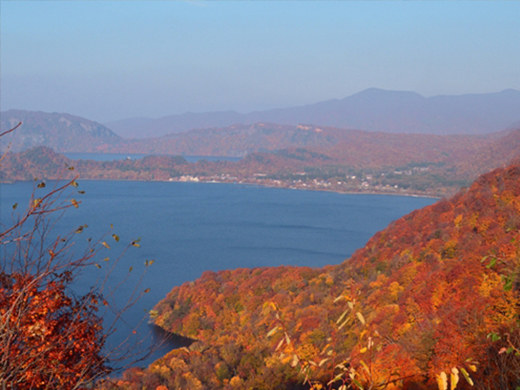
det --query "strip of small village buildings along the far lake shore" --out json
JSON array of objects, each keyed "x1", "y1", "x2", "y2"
[{"x1": 169, "y1": 174, "x2": 446, "y2": 197}]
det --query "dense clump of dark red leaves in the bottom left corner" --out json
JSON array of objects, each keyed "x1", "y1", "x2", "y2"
[{"x1": 0, "y1": 273, "x2": 109, "y2": 389}]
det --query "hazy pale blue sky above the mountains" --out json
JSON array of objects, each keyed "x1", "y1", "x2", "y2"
[{"x1": 0, "y1": 0, "x2": 520, "y2": 122}]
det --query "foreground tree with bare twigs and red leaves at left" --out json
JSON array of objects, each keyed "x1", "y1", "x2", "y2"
[{"x1": 0, "y1": 124, "x2": 152, "y2": 390}]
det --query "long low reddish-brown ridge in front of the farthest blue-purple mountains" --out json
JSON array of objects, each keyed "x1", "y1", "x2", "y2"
[{"x1": 104, "y1": 123, "x2": 494, "y2": 166}]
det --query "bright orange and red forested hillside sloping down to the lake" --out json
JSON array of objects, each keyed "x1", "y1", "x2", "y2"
[{"x1": 101, "y1": 161, "x2": 520, "y2": 390}]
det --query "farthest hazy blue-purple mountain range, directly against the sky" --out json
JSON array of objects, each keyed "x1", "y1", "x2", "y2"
[{"x1": 106, "y1": 88, "x2": 520, "y2": 138}]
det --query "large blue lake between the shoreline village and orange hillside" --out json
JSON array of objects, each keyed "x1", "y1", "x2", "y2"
[{"x1": 0, "y1": 181, "x2": 435, "y2": 365}]
